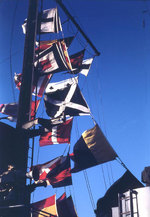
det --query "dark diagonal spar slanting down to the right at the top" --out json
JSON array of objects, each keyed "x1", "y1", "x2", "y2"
[{"x1": 56, "y1": 0, "x2": 100, "y2": 56}]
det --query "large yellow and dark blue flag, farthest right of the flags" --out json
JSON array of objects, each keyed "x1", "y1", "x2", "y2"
[{"x1": 70, "y1": 125, "x2": 117, "y2": 172}]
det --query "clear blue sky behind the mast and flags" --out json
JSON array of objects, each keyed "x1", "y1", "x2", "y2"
[{"x1": 0, "y1": 0, "x2": 150, "y2": 217}]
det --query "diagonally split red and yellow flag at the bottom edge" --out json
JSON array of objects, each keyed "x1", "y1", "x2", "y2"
[{"x1": 31, "y1": 195, "x2": 58, "y2": 217}]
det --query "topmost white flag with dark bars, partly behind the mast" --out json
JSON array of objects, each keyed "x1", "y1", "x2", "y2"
[{"x1": 22, "y1": 8, "x2": 62, "y2": 34}]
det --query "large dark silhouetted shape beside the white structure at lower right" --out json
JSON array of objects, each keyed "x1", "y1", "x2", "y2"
[{"x1": 95, "y1": 170, "x2": 143, "y2": 216}]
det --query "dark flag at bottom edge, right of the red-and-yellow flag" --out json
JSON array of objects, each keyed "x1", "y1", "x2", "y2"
[{"x1": 57, "y1": 196, "x2": 78, "y2": 217}]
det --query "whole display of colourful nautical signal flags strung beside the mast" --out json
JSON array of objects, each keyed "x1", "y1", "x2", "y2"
[{"x1": 0, "y1": 5, "x2": 123, "y2": 217}]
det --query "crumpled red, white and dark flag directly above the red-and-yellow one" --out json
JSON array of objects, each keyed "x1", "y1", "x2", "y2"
[{"x1": 31, "y1": 156, "x2": 72, "y2": 188}]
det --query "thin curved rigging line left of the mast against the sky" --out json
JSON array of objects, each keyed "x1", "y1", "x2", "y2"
[{"x1": 10, "y1": 0, "x2": 18, "y2": 102}]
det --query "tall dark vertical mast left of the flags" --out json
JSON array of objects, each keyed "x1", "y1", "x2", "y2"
[{"x1": 15, "y1": 0, "x2": 38, "y2": 217}]
